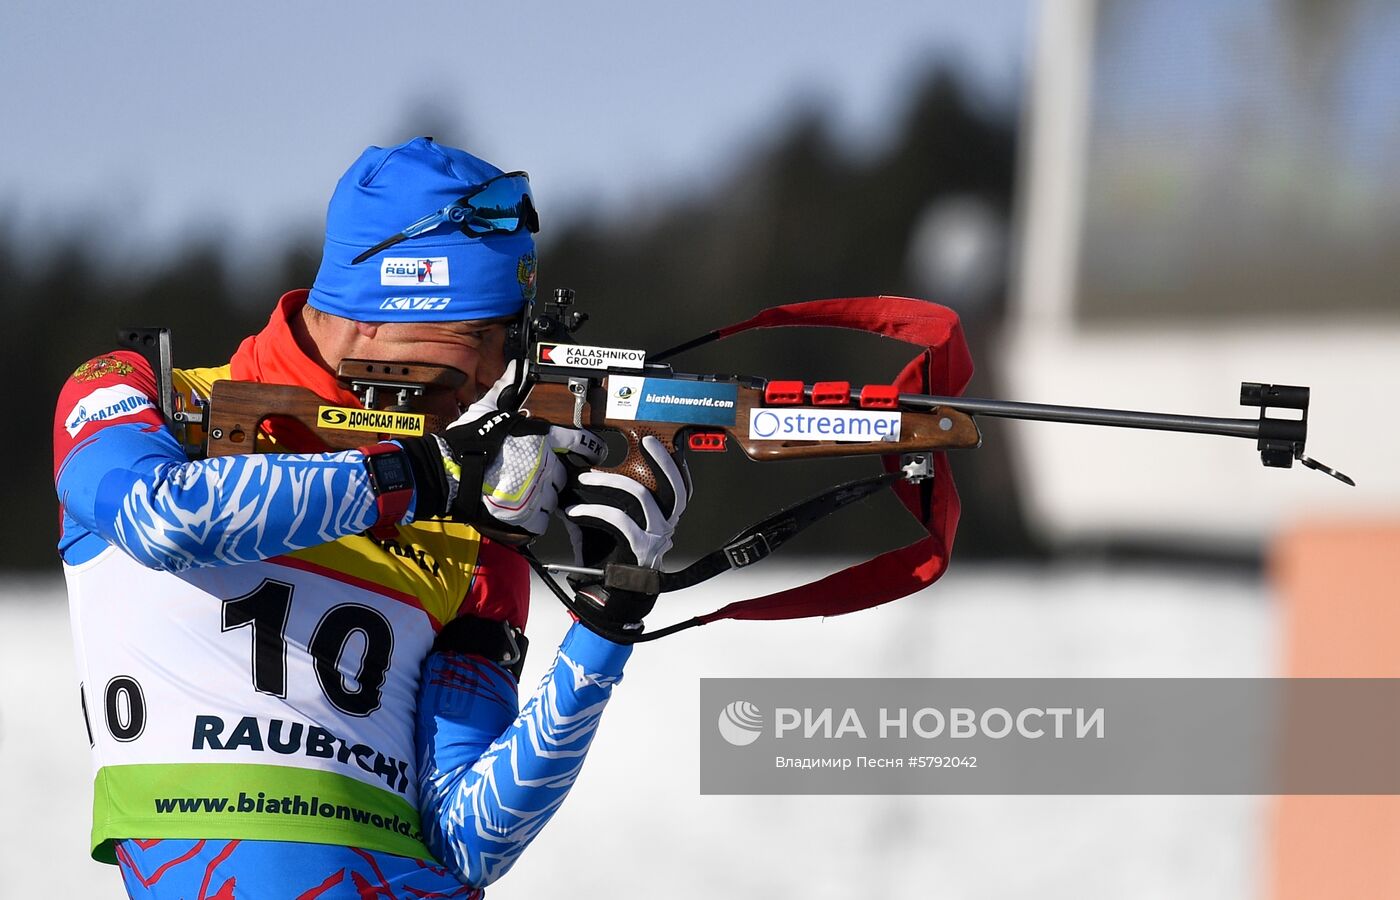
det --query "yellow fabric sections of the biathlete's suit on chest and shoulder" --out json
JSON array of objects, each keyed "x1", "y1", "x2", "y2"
[{"x1": 172, "y1": 365, "x2": 482, "y2": 627}]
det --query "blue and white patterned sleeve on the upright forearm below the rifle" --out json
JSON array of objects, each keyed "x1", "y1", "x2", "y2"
[{"x1": 417, "y1": 623, "x2": 631, "y2": 887}]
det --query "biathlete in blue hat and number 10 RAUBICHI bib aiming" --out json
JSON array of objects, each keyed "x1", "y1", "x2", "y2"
[{"x1": 53, "y1": 139, "x2": 689, "y2": 900}]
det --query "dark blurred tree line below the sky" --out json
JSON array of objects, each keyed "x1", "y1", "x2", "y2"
[{"x1": 0, "y1": 70, "x2": 1033, "y2": 571}]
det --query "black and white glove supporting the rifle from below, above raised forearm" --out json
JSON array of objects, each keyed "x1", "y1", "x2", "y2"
[{"x1": 563, "y1": 435, "x2": 690, "y2": 631}]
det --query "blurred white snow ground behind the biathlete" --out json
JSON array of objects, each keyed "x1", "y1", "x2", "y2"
[{"x1": 0, "y1": 563, "x2": 1280, "y2": 900}]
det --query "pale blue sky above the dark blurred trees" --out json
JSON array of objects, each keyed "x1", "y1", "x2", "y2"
[{"x1": 0, "y1": 0, "x2": 1029, "y2": 274}]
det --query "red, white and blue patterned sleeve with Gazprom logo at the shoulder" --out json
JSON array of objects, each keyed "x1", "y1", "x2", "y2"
[{"x1": 53, "y1": 353, "x2": 389, "y2": 571}]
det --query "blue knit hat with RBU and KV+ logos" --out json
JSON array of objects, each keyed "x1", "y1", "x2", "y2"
[{"x1": 308, "y1": 137, "x2": 535, "y2": 322}]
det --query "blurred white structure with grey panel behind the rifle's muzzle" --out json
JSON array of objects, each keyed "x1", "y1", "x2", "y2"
[{"x1": 1002, "y1": 0, "x2": 1400, "y2": 547}]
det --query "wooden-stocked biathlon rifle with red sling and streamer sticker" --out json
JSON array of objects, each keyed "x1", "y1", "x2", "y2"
[{"x1": 122, "y1": 288, "x2": 1355, "y2": 642}]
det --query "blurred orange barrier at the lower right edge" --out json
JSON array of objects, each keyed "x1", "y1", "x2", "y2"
[{"x1": 1268, "y1": 522, "x2": 1400, "y2": 900}]
